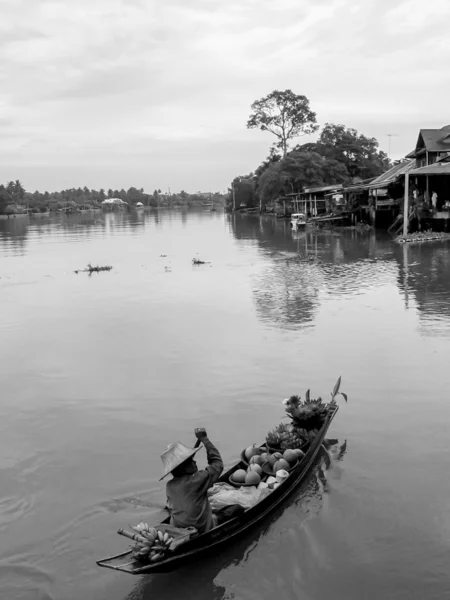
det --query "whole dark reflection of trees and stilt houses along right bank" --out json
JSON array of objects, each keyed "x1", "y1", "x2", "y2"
[{"x1": 232, "y1": 215, "x2": 450, "y2": 335}]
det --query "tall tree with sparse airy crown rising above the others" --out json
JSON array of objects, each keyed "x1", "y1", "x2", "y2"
[{"x1": 247, "y1": 90, "x2": 318, "y2": 156}]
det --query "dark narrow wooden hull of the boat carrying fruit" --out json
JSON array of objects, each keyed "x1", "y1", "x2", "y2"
[{"x1": 97, "y1": 403, "x2": 339, "y2": 575}]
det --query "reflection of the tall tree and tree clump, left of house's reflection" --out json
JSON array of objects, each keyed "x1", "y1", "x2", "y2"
[{"x1": 232, "y1": 214, "x2": 396, "y2": 328}]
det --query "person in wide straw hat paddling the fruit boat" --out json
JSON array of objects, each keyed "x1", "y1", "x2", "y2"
[{"x1": 161, "y1": 428, "x2": 223, "y2": 533}]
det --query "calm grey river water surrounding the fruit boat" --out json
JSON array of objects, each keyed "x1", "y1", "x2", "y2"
[{"x1": 0, "y1": 212, "x2": 450, "y2": 600}]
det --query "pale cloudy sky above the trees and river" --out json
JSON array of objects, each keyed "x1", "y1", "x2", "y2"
[{"x1": 0, "y1": 0, "x2": 450, "y2": 192}]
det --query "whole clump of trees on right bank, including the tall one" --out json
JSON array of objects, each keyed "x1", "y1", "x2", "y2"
[{"x1": 228, "y1": 90, "x2": 390, "y2": 208}]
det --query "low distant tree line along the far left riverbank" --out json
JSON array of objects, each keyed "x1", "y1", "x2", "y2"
[{"x1": 0, "y1": 180, "x2": 225, "y2": 213}]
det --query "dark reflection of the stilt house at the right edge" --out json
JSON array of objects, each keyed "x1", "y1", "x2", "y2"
[{"x1": 395, "y1": 242, "x2": 450, "y2": 334}]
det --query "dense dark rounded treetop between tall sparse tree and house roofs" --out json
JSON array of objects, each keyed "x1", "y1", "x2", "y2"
[{"x1": 299, "y1": 123, "x2": 390, "y2": 179}]
